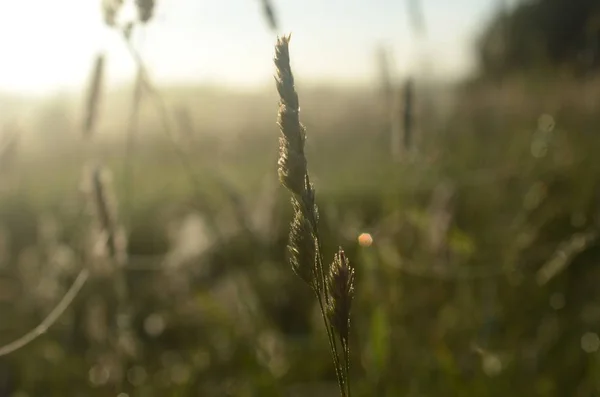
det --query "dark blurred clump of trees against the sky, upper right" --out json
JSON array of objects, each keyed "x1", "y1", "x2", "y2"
[{"x1": 477, "y1": 0, "x2": 600, "y2": 77}]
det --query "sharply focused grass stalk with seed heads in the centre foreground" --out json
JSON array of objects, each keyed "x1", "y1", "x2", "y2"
[{"x1": 274, "y1": 36, "x2": 354, "y2": 397}]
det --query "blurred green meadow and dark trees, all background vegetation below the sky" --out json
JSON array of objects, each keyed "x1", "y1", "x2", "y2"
[{"x1": 0, "y1": 0, "x2": 600, "y2": 397}]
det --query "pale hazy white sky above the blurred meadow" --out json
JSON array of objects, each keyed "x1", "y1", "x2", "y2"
[{"x1": 0, "y1": 0, "x2": 506, "y2": 94}]
